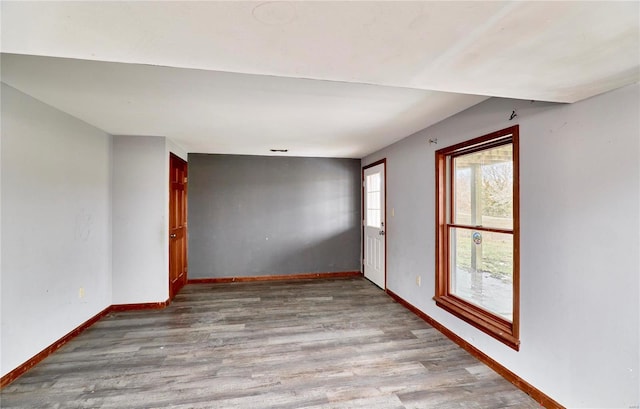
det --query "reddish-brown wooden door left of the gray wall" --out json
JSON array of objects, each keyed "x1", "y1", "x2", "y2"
[{"x1": 169, "y1": 154, "x2": 187, "y2": 299}]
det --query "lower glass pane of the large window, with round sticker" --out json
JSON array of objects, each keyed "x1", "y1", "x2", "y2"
[{"x1": 449, "y1": 227, "x2": 513, "y2": 321}]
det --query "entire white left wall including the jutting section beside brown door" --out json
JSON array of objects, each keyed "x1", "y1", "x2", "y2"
[{"x1": 0, "y1": 84, "x2": 187, "y2": 375}]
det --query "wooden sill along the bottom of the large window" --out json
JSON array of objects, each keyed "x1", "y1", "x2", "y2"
[{"x1": 433, "y1": 295, "x2": 520, "y2": 351}]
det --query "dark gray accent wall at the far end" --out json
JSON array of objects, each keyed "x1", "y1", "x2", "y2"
[{"x1": 188, "y1": 154, "x2": 361, "y2": 279}]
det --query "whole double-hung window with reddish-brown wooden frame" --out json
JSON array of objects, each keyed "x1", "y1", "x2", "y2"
[{"x1": 434, "y1": 126, "x2": 520, "y2": 350}]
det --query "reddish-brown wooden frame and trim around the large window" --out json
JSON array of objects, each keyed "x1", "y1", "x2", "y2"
[{"x1": 434, "y1": 125, "x2": 520, "y2": 351}]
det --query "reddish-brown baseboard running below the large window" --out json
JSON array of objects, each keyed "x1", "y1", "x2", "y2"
[{"x1": 385, "y1": 289, "x2": 565, "y2": 409}]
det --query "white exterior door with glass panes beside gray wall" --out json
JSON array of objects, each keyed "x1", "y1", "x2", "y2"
[{"x1": 363, "y1": 162, "x2": 386, "y2": 290}]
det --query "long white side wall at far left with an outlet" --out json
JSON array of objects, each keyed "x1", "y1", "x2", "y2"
[{"x1": 0, "y1": 84, "x2": 111, "y2": 375}]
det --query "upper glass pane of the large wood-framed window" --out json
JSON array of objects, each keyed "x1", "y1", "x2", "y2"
[{"x1": 453, "y1": 144, "x2": 513, "y2": 229}]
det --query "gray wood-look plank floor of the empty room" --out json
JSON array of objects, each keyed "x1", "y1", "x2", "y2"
[{"x1": 0, "y1": 278, "x2": 539, "y2": 409}]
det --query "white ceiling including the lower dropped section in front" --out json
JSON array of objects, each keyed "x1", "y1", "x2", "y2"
[{"x1": 0, "y1": 1, "x2": 640, "y2": 157}]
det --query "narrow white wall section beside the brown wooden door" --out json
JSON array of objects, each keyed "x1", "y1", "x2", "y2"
[{"x1": 113, "y1": 136, "x2": 169, "y2": 304}]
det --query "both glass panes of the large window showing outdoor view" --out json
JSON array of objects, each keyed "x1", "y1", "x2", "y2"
[{"x1": 450, "y1": 144, "x2": 513, "y2": 320}]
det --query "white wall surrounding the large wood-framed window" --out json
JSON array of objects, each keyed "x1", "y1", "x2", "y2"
[{"x1": 363, "y1": 84, "x2": 640, "y2": 408}]
